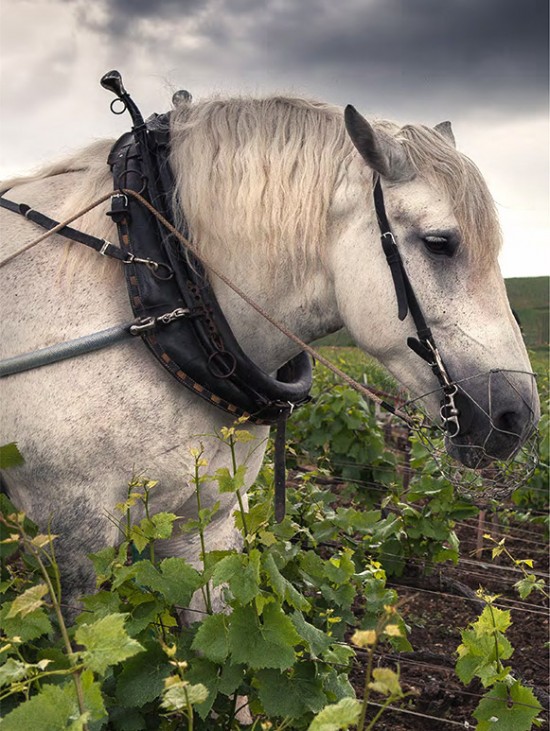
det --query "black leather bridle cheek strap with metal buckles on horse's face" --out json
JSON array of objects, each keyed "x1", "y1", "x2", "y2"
[{"x1": 373, "y1": 176, "x2": 460, "y2": 438}]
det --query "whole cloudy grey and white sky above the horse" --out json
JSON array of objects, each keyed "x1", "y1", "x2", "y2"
[{"x1": 0, "y1": 0, "x2": 550, "y2": 277}]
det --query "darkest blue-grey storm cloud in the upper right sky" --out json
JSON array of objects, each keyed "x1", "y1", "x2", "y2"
[{"x1": 260, "y1": 0, "x2": 548, "y2": 112}]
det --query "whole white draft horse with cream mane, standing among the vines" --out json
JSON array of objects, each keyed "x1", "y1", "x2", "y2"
[{"x1": 0, "y1": 91, "x2": 539, "y2": 599}]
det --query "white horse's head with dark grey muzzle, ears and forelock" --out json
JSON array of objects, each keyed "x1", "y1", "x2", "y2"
[{"x1": 342, "y1": 107, "x2": 540, "y2": 467}]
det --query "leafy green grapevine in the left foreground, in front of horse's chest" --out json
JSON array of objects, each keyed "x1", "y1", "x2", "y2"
[{"x1": 0, "y1": 429, "x2": 406, "y2": 731}]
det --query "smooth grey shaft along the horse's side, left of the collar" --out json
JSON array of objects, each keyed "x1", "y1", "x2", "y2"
[{"x1": 0, "y1": 323, "x2": 132, "y2": 378}]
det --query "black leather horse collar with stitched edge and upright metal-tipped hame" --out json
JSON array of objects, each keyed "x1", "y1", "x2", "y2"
[{"x1": 101, "y1": 71, "x2": 312, "y2": 424}]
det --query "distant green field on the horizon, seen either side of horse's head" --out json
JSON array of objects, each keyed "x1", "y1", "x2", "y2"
[{"x1": 320, "y1": 277, "x2": 550, "y2": 350}]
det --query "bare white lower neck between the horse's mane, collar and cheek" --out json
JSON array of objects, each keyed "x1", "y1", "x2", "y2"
[{"x1": 203, "y1": 166, "x2": 378, "y2": 372}]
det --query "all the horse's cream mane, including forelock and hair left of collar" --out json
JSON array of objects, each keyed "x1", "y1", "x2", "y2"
[{"x1": 1, "y1": 96, "x2": 501, "y2": 279}]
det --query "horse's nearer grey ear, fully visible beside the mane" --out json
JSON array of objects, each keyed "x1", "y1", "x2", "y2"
[{"x1": 344, "y1": 104, "x2": 413, "y2": 182}]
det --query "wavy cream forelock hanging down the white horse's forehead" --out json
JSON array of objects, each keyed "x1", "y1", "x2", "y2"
[{"x1": 396, "y1": 125, "x2": 502, "y2": 271}]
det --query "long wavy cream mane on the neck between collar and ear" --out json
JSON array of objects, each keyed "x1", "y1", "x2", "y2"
[{"x1": 171, "y1": 96, "x2": 353, "y2": 278}]
